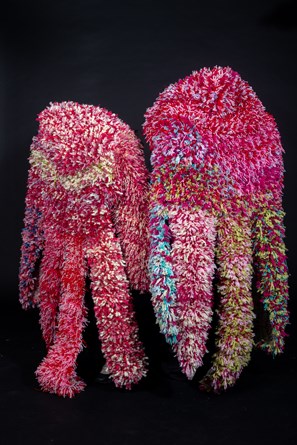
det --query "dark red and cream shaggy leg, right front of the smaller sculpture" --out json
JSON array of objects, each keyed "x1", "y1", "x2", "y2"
[{"x1": 87, "y1": 227, "x2": 146, "y2": 389}]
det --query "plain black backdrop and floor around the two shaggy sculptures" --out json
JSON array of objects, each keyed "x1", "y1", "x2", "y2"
[{"x1": 0, "y1": 0, "x2": 297, "y2": 444}]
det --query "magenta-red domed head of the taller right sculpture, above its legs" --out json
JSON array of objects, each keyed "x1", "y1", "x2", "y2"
[{"x1": 144, "y1": 66, "x2": 283, "y2": 199}]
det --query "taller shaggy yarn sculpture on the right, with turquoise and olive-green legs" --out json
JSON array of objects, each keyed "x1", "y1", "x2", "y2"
[{"x1": 144, "y1": 67, "x2": 288, "y2": 392}]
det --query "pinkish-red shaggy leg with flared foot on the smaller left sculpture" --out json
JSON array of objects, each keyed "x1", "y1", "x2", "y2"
[{"x1": 36, "y1": 237, "x2": 86, "y2": 397}]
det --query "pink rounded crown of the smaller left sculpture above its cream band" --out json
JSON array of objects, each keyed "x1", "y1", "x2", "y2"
[{"x1": 34, "y1": 102, "x2": 136, "y2": 175}]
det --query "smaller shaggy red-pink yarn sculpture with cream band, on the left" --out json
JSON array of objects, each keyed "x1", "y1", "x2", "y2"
[{"x1": 19, "y1": 102, "x2": 148, "y2": 397}]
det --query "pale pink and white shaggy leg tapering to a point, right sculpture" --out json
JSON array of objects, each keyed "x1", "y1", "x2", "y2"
[{"x1": 170, "y1": 209, "x2": 216, "y2": 379}]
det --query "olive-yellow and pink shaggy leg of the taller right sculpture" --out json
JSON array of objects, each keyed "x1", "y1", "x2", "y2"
[{"x1": 201, "y1": 215, "x2": 254, "y2": 391}]
